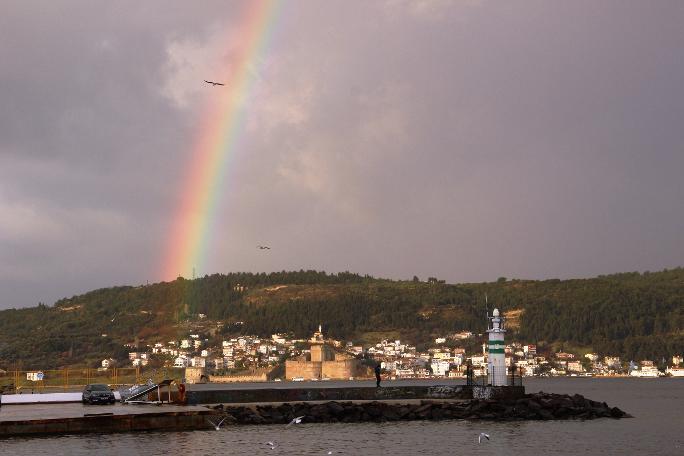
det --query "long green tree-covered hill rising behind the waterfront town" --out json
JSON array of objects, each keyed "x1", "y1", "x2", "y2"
[{"x1": 0, "y1": 268, "x2": 684, "y2": 369}]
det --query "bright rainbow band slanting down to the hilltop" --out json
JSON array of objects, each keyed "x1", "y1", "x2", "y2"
[{"x1": 161, "y1": 0, "x2": 281, "y2": 279}]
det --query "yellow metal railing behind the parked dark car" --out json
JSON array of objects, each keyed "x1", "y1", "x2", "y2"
[{"x1": 0, "y1": 367, "x2": 184, "y2": 394}]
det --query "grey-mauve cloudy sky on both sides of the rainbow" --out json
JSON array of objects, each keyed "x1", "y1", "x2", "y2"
[{"x1": 0, "y1": 0, "x2": 684, "y2": 308}]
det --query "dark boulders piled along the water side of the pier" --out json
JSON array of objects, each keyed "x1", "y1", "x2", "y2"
[{"x1": 214, "y1": 393, "x2": 629, "y2": 424}]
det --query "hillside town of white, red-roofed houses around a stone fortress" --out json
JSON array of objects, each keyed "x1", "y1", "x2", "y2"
[{"x1": 115, "y1": 327, "x2": 684, "y2": 381}]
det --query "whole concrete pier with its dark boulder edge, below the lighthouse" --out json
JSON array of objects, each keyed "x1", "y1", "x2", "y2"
[{"x1": 0, "y1": 385, "x2": 629, "y2": 438}]
